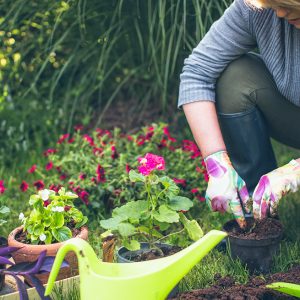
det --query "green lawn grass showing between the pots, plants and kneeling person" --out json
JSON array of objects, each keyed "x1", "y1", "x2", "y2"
[{"x1": 0, "y1": 135, "x2": 300, "y2": 299}]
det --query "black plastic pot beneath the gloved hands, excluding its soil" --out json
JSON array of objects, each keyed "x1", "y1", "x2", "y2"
[{"x1": 223, "y1": 220, "x2": 283, "y2": 274}]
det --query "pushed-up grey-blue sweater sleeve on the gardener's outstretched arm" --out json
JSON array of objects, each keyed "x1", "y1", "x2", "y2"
[{"x1": 178, "y1": 0, "x2": 256, "y2": 107}]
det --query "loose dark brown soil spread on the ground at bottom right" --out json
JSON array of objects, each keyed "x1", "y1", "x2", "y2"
[{"x1": 173, "y1": 265, "x2": 300, "y2": 300}]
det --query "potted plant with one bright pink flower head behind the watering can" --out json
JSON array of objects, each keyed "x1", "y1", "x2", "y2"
[{"x1": 100, "y1": 153, "x2": 203, "y2": 262}]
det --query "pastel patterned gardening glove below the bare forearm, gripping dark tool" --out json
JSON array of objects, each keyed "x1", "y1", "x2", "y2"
[{"x1": 204, "y1": 151, "x2": 250, "y2": 228}]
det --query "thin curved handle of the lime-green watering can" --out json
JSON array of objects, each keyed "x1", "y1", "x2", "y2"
[{"x1": 45, "y1": 238, "x2": 97, "y2": 296}]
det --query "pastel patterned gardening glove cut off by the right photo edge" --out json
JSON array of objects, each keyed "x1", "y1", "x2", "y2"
[{"x1": 253, "y1": 160, "x2": 300, "y2": 219}]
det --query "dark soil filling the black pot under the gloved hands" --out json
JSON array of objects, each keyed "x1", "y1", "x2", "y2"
[{"x1": 224, "y1": 218, "x2": 283, "y2": 240}]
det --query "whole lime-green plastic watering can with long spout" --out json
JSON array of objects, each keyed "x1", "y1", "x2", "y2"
[{"x1": 45, "y1": 230, "x2": 227, "y2": 300}]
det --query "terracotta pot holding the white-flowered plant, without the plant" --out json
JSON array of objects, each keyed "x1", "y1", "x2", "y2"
[{"x1": 8, "y1": 226, "x2": 88, "y2": 285}]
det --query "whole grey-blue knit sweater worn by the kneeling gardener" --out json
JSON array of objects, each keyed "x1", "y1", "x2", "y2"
[{"x1": 178, "y1": 0, "x2": 300, "y2": 107}]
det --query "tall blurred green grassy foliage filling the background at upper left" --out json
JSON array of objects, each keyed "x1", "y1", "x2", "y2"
[{"x1": 0, "y1": 0, "x2": 231, "y2": 163}]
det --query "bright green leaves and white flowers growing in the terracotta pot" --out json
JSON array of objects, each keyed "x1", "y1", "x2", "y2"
[{"x1": 19, "y1": 188, "x2": 87, "y2": 244}]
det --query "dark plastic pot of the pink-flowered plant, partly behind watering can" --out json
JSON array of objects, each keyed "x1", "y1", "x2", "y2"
[{"x1": 116, "y1": 243, "x2": 179, "y2": 298}]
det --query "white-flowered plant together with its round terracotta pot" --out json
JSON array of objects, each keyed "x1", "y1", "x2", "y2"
[{"x1": 8, "y1": 188, "x2": 88, "y2": 284}]
